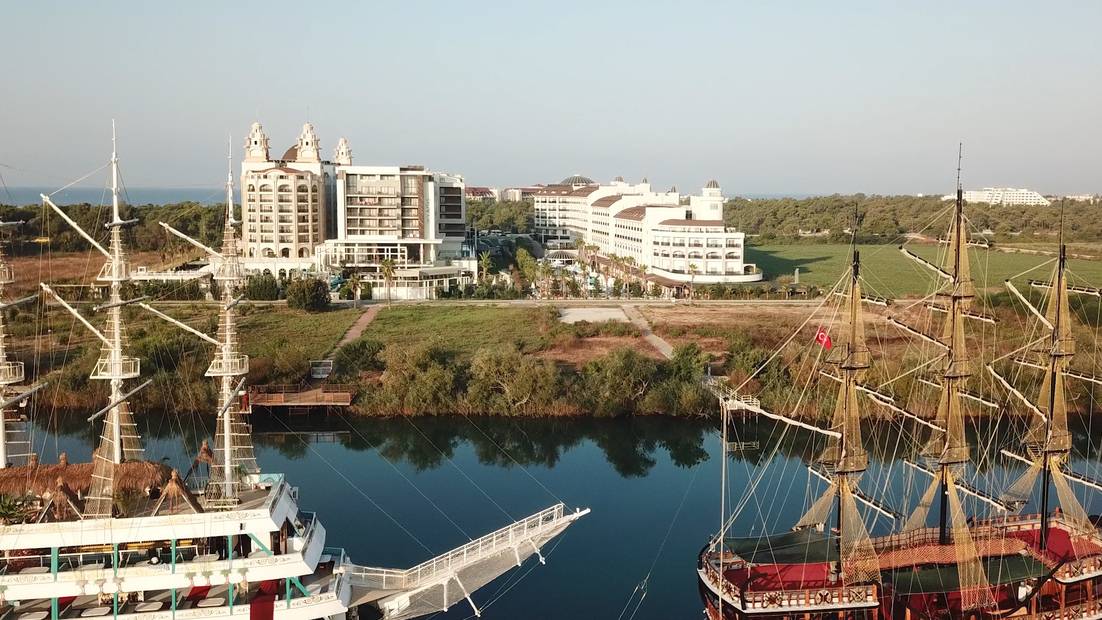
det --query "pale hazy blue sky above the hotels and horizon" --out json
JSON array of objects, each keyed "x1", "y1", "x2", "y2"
[{"x1": 0, "y1": 0, "x2": 1102, "y2": 194}]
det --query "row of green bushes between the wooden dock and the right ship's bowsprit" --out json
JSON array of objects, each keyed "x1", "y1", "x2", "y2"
[{"x1": 335, "y1": 338, "x2": 717, "y2": 417}]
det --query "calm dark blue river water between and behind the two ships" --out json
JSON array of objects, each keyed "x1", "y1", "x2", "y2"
[{"x1": 35, "y1": 415, "x2": 1102, "y2": 620}]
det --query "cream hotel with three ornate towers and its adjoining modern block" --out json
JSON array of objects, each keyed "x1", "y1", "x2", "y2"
[{"x1": 241, "y1": 122, "x2": 469, "y2": 298}]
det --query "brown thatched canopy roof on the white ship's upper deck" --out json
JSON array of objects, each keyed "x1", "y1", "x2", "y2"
[{"x1": 0, "y1": 458, "x2": 172, "y2": 497}]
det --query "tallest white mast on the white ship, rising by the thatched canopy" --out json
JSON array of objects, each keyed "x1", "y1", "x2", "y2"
[{"x1": 41, "y1": 120, "x2": 149, "y2": 519}]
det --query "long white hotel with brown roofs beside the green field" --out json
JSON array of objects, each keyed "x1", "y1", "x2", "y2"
[{"x1": 533, "y1": 175, "x2": 761, "y2": 287}]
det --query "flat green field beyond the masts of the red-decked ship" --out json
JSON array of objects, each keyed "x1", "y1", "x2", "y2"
[{"x1": 746, "y1": 243, "x2": 1102, "y2": 297}]
